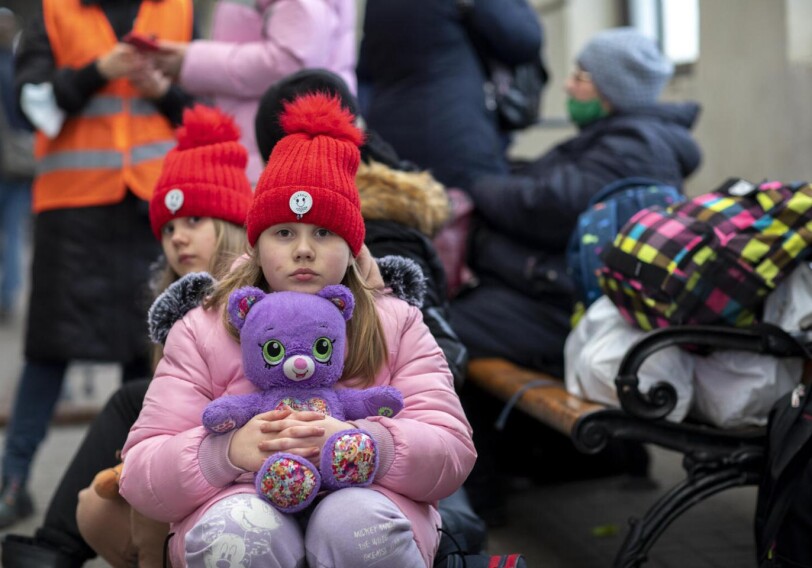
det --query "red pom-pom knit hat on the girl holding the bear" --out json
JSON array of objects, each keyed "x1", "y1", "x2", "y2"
[{"x1": 246, "y1": 93, "x2": 364, "y2": 255}]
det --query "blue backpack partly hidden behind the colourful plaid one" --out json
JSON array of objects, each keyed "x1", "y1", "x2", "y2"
[{"x1": 567, "y1": 177, "x2": 685, "y2": 325}]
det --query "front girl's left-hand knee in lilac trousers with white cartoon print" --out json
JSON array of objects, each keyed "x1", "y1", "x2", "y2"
[{"x1": 185, "y1": 494, "x2": 304, "y2": 568}]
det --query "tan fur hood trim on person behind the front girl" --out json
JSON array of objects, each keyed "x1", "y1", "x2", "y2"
[{"x1": 355, "y1": 160, "x2": 450, "y2": 238}]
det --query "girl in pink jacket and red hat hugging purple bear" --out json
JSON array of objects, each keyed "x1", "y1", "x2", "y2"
[{"x1": 120, "y1": 95, "x2": 476, "y2": 568}]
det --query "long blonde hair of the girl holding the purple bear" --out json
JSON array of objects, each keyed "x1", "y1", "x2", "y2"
[{"x1": 203, "y1": 244, "x2": 388, "y2": 387}]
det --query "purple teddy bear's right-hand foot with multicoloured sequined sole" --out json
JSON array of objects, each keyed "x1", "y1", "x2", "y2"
[{"x1": 321, "y1": 430, "x2": 378, "y2": 489}]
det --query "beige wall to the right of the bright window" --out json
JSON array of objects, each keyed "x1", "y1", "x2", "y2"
[{"x1": 690, "y1": 0, "x2": 812, "y2": 193}]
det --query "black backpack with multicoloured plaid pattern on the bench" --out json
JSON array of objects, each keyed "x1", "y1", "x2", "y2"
[{"x1": 599, "y1": 179, "x2": 812, "y2": 330}]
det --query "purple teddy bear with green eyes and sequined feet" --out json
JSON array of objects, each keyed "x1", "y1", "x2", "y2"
[{"x1": 203, "y1": 285, "x2": 403, "y2": 513}]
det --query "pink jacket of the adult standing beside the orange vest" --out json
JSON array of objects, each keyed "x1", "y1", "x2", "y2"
[{"x1": 180, "y1": 0, "x2": 356, "y2": 184}]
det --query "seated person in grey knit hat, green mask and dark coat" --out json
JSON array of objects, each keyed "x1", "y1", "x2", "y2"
[{"x1": 451, "y1": 28, "x2": 702, "y2": 525}]
